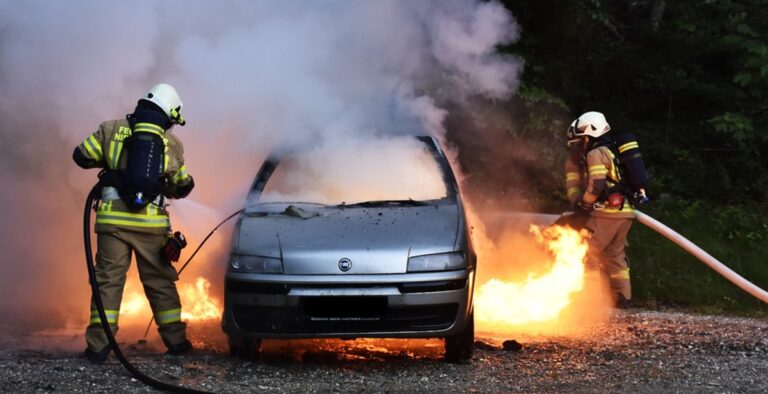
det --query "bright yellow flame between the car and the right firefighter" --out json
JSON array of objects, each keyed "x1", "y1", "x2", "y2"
[{"x1": 475, "y1": 225, "x2": 587, "y2": 332}]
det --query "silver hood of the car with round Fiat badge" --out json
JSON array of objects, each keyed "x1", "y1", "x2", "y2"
[{"x1": 235, "y1": 204, "x2": 463, "y2": 275}]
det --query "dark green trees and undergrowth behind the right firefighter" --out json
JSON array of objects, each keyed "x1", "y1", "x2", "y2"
[{"x1": 503, "y1": 0, "x2": 768, "y2": 310}]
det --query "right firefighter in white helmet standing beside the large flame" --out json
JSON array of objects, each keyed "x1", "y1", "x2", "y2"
[{"x1": 565, "y1": 112, "x2": 635, "y2": 308}]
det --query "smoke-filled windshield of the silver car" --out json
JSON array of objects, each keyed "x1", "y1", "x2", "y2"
[{"x1": 249, "y1": 138, "x2": 448, "y2": 206}]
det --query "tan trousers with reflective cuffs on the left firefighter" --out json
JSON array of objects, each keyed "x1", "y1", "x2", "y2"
[{"x1": 85, "y1": 230, "x2": 187, "y2": 352}]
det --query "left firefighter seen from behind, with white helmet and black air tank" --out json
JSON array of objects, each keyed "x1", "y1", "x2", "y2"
[{"x1": 73, "y1": 84, "x2": 194, "y2": 363}]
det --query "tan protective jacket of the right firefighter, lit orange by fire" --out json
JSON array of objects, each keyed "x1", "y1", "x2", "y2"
[{"x1": 565, "y1": 145, "x2": 635, "y2": 219}]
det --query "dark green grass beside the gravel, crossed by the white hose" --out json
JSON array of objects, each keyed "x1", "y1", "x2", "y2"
[{"x1": 627, "y1": 200, "x2": 768, "y2": 316}]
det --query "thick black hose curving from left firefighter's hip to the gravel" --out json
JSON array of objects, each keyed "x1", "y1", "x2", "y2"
[{"x1": 83, "y1": 184, "x2": 206, "y2": 393}]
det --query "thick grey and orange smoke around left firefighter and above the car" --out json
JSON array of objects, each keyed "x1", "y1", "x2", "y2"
[{"x1": 0, "y1": 0, "x2": 522, "y2": 326}]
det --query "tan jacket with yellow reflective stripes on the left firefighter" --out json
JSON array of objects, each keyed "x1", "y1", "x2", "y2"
[{"x1": 74, "y1": 119, "x2": 194, "y2": 234}]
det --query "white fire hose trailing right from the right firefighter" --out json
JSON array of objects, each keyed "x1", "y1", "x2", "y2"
[{"x1": 635, "y1": 210, "x2": 768, "y2": 304}]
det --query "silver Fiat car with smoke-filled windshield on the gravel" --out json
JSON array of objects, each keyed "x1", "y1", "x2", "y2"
[{"x1": 222, "y1": 137, "x2": 477, "y2": 362}]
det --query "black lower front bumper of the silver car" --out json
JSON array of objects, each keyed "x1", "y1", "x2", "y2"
[{"x1": 232, "y1": 297, "x2": 459, "y2": 334}]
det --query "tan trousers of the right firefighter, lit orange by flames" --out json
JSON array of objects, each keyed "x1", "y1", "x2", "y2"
[{"x1": 586, "y1": 216, "x2": 634, "y2": 300}]
